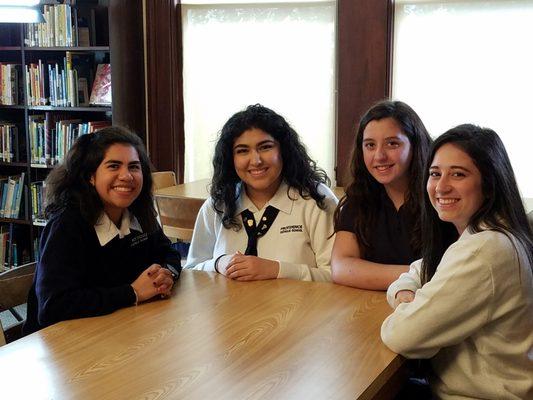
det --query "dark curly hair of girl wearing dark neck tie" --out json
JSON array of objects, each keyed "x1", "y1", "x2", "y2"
[{"x1": 211, "y1": 104, "x2": 330, "y2": 230}]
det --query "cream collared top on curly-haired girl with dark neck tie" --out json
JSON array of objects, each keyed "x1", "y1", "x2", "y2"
[{"x1": 185, "y1": 182, "x2": 337, "y2": 281}]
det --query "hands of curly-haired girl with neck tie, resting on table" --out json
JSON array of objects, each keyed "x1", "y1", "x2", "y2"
[{"x1": 217, "y1": 252, "x2": 279, "y2": 281}]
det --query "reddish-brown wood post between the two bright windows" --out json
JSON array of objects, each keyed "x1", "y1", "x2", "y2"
[{"x1": 336, "y1": 0, "x2": 393, "y2": 186}]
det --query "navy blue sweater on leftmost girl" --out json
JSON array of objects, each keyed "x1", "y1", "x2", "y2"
[{"x1": 24, "y1": 209, "x2": 181, "y2": 334}]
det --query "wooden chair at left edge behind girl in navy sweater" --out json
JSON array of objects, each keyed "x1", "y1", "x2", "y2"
[{"x1": 0, "y1": 262, "x2": 36, "y2": 346}]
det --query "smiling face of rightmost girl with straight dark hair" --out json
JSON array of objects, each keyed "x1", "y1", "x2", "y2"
[{"x1": 427, "y1": 143, "x2": 484, "y2": 234}]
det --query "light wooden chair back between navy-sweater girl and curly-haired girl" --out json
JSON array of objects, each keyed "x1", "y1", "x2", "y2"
[{"x1": 155, "y1": 195, "x2": 204, "y2": 242}]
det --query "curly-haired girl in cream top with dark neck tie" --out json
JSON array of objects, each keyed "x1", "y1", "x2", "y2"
[{"x1": 186, "y1": 104, "x2": 337, "y2": 281}]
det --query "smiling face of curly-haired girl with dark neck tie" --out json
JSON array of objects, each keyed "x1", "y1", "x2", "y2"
[{"x1": 233, "y1": 128, "x2": 283, "y2": 208}]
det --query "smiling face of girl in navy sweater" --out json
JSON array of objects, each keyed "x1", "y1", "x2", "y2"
[{"x1": 91, "y1": 143, "x2": 143, "y2": 225}]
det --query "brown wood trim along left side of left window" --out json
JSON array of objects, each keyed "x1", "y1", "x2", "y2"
[{"x1": 145, "y1": 0, "x2": 185, "y2": 183}]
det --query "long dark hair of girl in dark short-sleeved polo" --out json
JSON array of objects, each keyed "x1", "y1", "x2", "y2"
[{"x1": 334, "y1": 100, "x2": 432, "y2": 254}]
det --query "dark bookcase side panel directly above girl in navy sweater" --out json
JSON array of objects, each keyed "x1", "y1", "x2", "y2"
[{"x1": 109, "y1": 0, "x2": 146, "y2": 143}]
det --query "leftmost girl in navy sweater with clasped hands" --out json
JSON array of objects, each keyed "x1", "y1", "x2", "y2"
[{"x1": 24, "y1": 127, "x2": 181, "y2": 333}]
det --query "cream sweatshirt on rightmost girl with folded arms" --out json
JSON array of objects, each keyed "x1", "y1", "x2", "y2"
[{"x1": 381, "y1": 229, "x2": 533, "y2": 399}]
